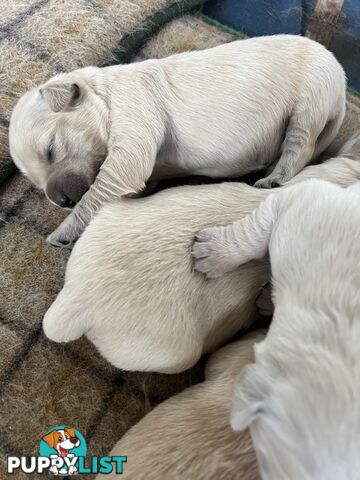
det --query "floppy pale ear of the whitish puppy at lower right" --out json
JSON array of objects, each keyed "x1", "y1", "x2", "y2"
[{"x1": 230, "y1": 364, "x2": 270, "y2": 431}]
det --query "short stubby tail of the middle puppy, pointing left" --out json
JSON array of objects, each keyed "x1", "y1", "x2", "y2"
[{"x1": 43, "y1": 287, "x2": 87, "y2": 342}]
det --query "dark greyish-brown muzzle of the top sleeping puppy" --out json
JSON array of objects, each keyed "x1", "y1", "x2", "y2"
[{"x1": 45, "y1": 173, "x2": 90, "y2": 208}]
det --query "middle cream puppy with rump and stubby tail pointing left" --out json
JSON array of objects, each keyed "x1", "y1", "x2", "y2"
[{"x1": 43, "y1": 158, "x2": 360, "y2": 373}]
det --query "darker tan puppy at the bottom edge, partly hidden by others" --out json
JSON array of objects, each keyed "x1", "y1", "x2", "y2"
[{"x1": 96, "y1": 330, "x2": 265, "y2": 480}]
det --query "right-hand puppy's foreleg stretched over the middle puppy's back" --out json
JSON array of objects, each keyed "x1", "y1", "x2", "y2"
[{"x1": 192, "y1": 194, "x2": 280, "y2": 278}]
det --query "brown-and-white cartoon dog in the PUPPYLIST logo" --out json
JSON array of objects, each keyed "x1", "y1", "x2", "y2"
[{"x1": 42, "y1": 427, "x2": 81, "y2": 475}]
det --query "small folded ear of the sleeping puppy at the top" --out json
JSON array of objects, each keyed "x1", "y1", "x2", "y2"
[{"x1": 40, "y1": 82, "x2": 81, "y2": 112}]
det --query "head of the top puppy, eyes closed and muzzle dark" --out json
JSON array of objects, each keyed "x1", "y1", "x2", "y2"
[{"x1": 9, "y1": 67, "x2": 108, "y2": 208}]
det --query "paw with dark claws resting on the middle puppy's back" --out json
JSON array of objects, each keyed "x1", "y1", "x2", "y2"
[{"x1": 192, "y1": 227, "x2": 237, "y2": 278}]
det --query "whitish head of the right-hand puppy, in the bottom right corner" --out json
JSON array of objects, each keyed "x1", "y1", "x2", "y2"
[{"x1": 231, "y1": 357, "x2": 360, "y2": 480}]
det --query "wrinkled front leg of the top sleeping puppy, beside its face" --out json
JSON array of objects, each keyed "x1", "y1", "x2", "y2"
[{"x1": 48, "y1": 85, "x2": 166, "y2": 246}]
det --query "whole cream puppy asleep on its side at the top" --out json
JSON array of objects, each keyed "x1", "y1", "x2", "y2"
[{"x1": 10, "y1": 35, "x2": 345, "y2": 245}]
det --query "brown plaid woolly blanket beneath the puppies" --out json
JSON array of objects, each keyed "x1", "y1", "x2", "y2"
[{"x1": 0, "y1": 0, "x2": 358, "y2": 479}]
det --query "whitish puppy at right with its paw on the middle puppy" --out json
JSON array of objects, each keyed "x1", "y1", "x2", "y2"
[{"x1": 194, "y1": 180, "x2": 360, "y2": 480}]
